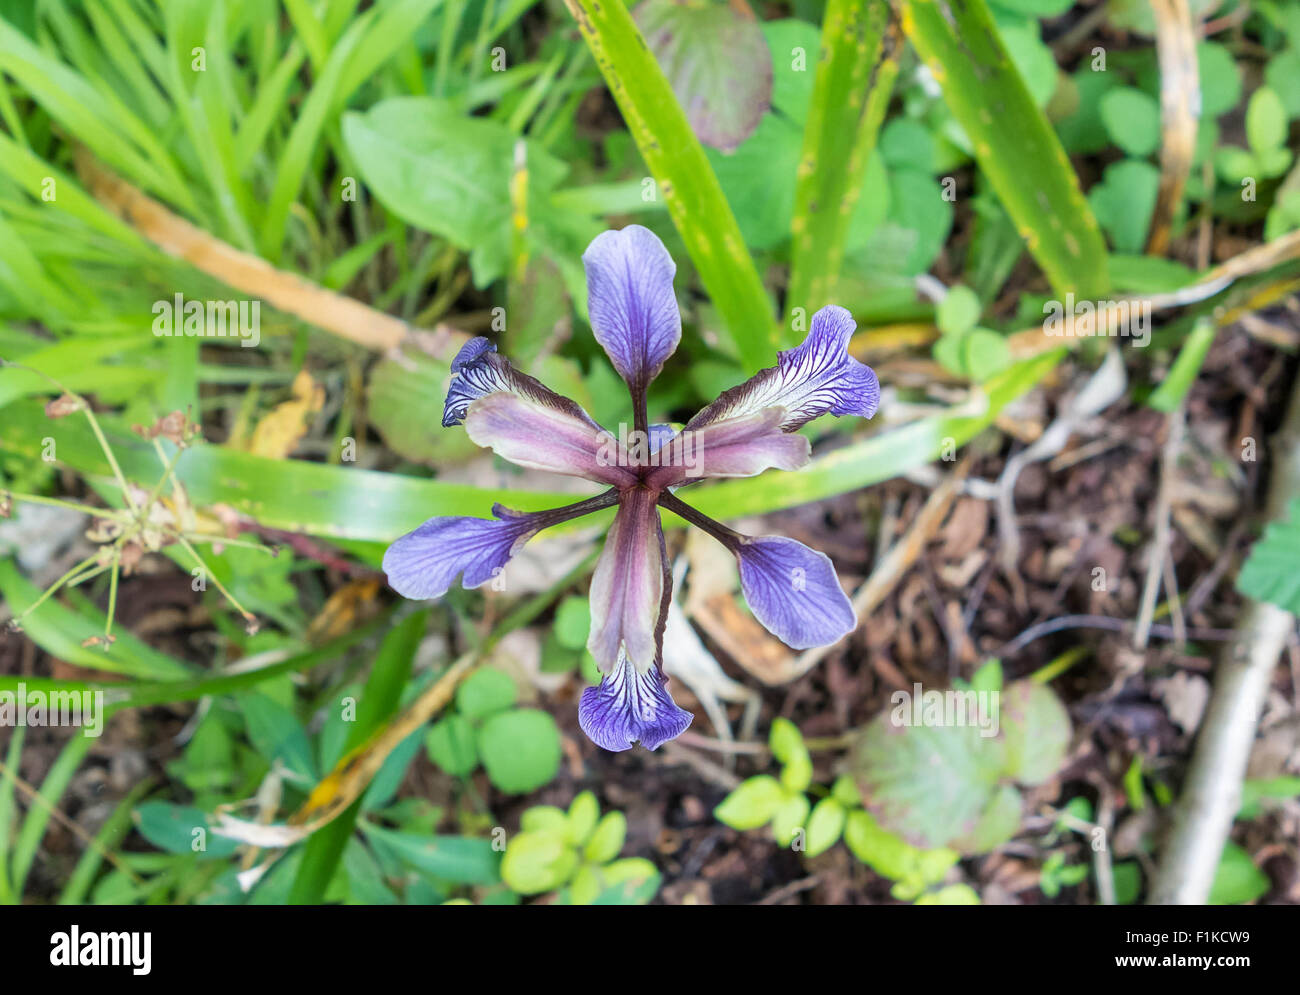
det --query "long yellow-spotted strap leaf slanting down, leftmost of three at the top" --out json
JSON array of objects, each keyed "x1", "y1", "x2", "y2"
[{"x1": 568, "y1": 0, "x2": 776, "y2": 372}]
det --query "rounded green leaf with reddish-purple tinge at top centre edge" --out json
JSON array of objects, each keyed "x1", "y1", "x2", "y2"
[{"x1": 633, "y1": 0, "x2": 772, "y2": 152}]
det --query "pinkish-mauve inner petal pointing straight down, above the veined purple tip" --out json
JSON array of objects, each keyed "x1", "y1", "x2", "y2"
[{"x1": 586, "y1": 488, "x2": 663, "y2": 674}]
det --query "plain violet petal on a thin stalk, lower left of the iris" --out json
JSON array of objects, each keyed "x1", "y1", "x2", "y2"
[{"x1": 384, "y1": 505, "x2": 542, "y2": 598}]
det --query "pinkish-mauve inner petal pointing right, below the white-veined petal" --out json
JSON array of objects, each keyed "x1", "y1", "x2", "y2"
[{"x1": 646, "y1": 407, "x2": 810, "y2": 490}]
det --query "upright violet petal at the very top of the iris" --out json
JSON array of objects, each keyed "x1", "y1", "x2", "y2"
[{"x1": 582, "y1": 225, "x2": 681, "y2": 390}]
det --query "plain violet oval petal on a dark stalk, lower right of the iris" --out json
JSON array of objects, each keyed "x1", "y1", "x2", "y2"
[{"x1": 735, "y1": 536, "x2": 858, "y2": 649}]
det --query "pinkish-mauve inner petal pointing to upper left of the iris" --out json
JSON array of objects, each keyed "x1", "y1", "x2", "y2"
[{"x1": 465, "y1": 393, "x2": 636, "y2": 488}]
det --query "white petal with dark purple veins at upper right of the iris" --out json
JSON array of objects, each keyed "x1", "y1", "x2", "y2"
[{"x1": 686, "y1": 304, "x2": 880, "y2": 432}]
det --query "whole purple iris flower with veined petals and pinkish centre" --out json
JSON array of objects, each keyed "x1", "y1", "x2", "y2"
[{"x1": 384, "y1": 225, "x2": 880, "y2": 750}]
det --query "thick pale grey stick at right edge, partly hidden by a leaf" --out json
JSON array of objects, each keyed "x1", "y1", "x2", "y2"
[{"x1": 1151, "y1": 364, "x2": 1300, "y2": 905}]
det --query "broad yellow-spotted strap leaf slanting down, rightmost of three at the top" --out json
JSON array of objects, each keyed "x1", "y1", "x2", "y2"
[{"x1": 901, "y1": 0, "x2": 1108, "y2": 297}]
